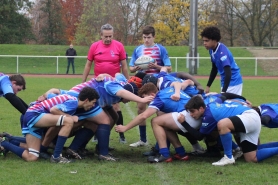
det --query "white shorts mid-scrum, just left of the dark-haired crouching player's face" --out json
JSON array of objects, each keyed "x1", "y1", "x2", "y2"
[{"x1": 172, "y1": 110, "x2": 202, "y2": 132}]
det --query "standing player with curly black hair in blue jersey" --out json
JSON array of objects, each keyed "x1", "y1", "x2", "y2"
[{"x1": 201, "y1": 26, "x2": 242, "y2": 95}]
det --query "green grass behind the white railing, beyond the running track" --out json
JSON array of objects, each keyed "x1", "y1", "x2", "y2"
[{"x1": 0, "y1": 44, "x2": 268, "y2": 76}]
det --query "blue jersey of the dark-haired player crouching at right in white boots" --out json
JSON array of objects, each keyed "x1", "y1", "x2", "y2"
[{"x1": 200, "y1": 99, "x2": 251, "y2": 134}]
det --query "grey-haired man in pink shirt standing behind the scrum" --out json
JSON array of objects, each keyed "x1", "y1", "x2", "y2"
[{"x1": 82, "y1": 24, "x2": 129, "y2": 143}]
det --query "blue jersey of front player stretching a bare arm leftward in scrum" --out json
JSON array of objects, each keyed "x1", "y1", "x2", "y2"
[{"x1": 149, "y1": 87, "x2": 190, "y2": 113}]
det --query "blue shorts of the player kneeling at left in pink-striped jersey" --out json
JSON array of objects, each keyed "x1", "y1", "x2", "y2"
[{"x1": 22, "y1": 112, "x2": 47, "y2": 139}]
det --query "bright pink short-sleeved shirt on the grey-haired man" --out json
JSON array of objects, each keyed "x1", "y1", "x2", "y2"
[{"x1": 87, "y1": 40, "x2": 126, "y2": 77}]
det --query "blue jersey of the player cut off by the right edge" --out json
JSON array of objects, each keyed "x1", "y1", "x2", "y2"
[{"x1": 259, "y1": 103, "x2": 278, "y2": 128}]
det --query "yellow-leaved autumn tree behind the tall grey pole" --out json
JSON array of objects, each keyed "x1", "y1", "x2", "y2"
[{"x1": 154, "y1": 0, "x2": 215, "y2": 45}]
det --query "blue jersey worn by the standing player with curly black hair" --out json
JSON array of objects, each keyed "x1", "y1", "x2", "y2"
[{"x1": 209, "y1": 42, "x2": 242, "y2": 87}]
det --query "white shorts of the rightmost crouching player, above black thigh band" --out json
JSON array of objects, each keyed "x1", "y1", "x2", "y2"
[{"x1": 237, "y1": 109, "x2": 261, "y2": 145}]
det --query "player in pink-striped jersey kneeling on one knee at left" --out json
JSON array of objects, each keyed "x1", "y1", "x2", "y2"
[{"x1": 1, "y1": 87, "x2": 99, "y2": 163}]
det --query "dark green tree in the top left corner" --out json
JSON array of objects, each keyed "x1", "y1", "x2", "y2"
[{"x1": 0, "y1": 0, "x2": 34, "y2": 44}]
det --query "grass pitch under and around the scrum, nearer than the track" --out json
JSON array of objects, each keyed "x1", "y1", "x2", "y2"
[{"x1": 0, "y1": 77, "x2": 278, "y2": 185}]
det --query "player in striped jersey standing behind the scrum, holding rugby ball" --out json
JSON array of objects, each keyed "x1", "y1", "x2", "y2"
[{"x1": 129, "y1": 26, "x2": 172, "y2": 147}]
